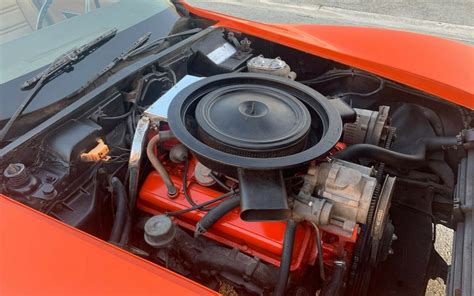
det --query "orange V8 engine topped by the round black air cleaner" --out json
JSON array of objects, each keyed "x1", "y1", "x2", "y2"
[{"x1": 138, "y1": 74, "x2": 395, "y2": 295}]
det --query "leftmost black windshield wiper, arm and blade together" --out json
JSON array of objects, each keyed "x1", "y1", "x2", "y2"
[{"x1": 0, "y1": 28, "x2": 117, "y2": 142}]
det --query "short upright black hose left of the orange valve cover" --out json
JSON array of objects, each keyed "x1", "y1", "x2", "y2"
[{"x1": 109, "y1": 177, "x2": 128, "y2": 243}]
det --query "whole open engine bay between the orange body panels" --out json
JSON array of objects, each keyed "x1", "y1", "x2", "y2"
[{"x1": 0, "y1": 27, "x2": 474, "y2": 295}]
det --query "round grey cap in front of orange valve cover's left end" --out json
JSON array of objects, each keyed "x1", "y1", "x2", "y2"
[{"x1": 145, "y1": 215, "x2": 176, "y2": 248}]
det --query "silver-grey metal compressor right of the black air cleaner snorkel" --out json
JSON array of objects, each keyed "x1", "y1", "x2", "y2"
[{"x1": 293, "y1": 160, "x2": 393, "y2": 231}]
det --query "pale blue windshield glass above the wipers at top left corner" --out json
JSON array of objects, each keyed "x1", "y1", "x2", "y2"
[{"x1": 0, "y1": 0, "x2": 171, "y2": 84}]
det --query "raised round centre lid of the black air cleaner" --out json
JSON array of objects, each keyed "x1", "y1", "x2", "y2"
[{"x1": 196, "y1": 84, "x2": 311, "y2": 150}]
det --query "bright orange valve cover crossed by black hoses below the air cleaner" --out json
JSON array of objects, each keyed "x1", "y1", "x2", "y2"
[{"x1": 137, "y1": 168, "x2": 316, "y2": 271}]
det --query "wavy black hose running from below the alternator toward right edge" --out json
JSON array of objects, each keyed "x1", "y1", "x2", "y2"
[{"x1": 334, "y1": 137, "x2": 458, "y2": 169}]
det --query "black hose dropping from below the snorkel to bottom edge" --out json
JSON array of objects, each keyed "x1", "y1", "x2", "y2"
[{"x1": 273, "y1": 220, "x2": 297, "y2": 296}]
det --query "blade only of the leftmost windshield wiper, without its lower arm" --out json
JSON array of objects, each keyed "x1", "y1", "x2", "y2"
[{"x1": 21, "y1": 28, "x2": 117, "y2": 89}]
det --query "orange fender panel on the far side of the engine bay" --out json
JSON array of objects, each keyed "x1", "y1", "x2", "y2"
[{"x1": 182, "y1": 1, "x2": 474, "y2": 109}]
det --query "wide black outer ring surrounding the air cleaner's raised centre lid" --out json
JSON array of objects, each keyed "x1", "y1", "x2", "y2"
[{"x1": 168, "y1": 73, "x2": 342, "y2": 171}]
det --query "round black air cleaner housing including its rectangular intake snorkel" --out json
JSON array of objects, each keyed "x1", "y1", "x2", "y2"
[{"x1": 168, "y1": 73, "x2": 342, "y2": 221}]
